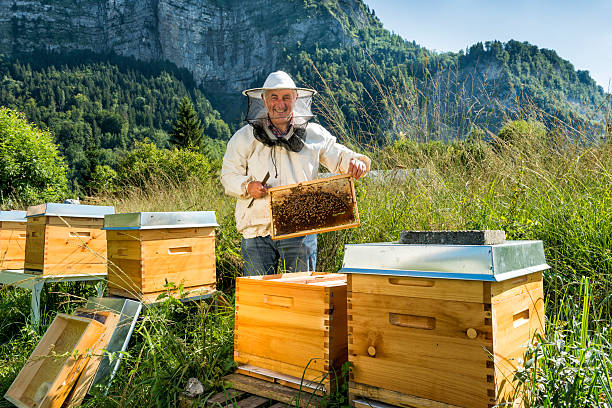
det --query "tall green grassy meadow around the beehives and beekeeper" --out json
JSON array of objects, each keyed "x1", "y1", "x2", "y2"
[{"x1": 0, "y1": 83, "x2": 612, "y2": 407}]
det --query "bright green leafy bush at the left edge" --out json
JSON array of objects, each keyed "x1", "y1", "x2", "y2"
[{"x1": 0, "y1": 107, "x2": 68, "y2": 204}]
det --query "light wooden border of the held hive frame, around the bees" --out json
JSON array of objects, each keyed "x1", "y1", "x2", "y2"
[{"x1": 268, "y1": 174, "x2": 361, "y2": 239}]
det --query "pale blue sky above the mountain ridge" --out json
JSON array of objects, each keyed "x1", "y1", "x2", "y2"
[{"x1": 365, "y1": 0, "x2": 612, "y2": 91}]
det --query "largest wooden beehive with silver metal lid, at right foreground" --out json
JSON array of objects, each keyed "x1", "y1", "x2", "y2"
[{"x1": 341, "y1": 241, "x2": 548, "y2": 408}]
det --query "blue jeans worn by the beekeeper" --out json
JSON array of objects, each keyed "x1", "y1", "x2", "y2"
[{"x1": 241, "y1": 235, "x2": 317, "y2": 276}]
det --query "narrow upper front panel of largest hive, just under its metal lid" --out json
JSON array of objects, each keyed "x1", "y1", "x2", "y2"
[{"x1": 349, "y1": 274, "x2": 483, "y2": 303}]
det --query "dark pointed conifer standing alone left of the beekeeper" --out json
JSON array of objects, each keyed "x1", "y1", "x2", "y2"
[{"x1": 170, "y1": 96, "x2": 204, "y2": 151}]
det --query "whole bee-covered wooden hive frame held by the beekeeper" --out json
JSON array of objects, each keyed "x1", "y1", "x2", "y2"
[{"x1": 268, "y1": 175, "x2": 359, "y2": 239}]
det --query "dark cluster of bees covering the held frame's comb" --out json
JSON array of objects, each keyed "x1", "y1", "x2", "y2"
[{"x1": 272, "y1": 186, "x2": 354, "y2": 235}]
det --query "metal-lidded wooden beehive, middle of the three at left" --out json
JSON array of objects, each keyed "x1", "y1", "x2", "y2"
[{"x1": 25, "y1": 203, "x2": 115, "y2": 275}]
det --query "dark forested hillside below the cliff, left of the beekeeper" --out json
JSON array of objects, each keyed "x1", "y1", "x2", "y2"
[{"x1": 0, "y1": 52, "x2": 230, "y2": 183}]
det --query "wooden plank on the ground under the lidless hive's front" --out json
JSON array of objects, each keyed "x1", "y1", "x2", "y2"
[{"x1": 223, "y1": 374, "x2": 322, "y2": 408}]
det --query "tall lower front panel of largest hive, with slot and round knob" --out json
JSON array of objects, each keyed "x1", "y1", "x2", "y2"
[{"x1": 348, "y1": 292, "x2": 494, "y2": 406}]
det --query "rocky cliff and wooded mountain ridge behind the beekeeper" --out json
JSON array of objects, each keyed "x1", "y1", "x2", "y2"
[{"x1": 0, "y1": 0, "x2": 610, "y2": 140}]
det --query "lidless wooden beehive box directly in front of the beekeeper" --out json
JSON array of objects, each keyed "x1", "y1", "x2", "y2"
[{"x1": 234, "y1": 272, "x2": 347, "y2": 392}]
